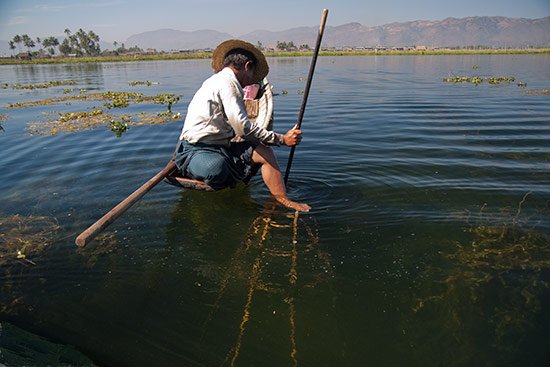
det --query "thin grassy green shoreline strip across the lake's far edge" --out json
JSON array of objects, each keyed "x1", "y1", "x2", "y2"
[{"x1": 0, "y1": 48, "x2": 550, "y2": 65}]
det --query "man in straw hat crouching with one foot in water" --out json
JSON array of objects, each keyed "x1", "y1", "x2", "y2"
[{"x1": 176, "y1": 40, "x2": 310, "y2": 212}]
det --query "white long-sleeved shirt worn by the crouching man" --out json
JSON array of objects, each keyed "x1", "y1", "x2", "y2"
[{"x1": 180, "y1": 67, "x2": 284, "y2": 146}]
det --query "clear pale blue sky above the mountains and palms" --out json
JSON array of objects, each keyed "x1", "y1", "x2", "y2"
[{"x1": 0, "y1": 0, "x2": 550, "y2": 43}]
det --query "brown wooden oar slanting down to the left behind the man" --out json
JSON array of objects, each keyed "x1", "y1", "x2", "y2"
[{"x1": 75, "y1": 161, "x2": 176, "y2": 247}]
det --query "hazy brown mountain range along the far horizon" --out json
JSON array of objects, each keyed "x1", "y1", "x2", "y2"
[{"x1": 125, "y1": 17, "x2": 550, "y2": 51}]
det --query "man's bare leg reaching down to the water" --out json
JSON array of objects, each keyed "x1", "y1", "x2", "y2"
[{"x1": 252, "y1": 144, "x2": 311, "y2": 212}]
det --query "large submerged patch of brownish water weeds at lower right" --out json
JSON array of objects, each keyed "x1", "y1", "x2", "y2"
[{"x1": 413, "y1": 193, "x2": 550, "y2": 353}]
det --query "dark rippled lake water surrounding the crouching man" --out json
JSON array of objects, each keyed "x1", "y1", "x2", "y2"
[{"x1": 0, "y1": 55, "x2": 550, "y2": 366}]
